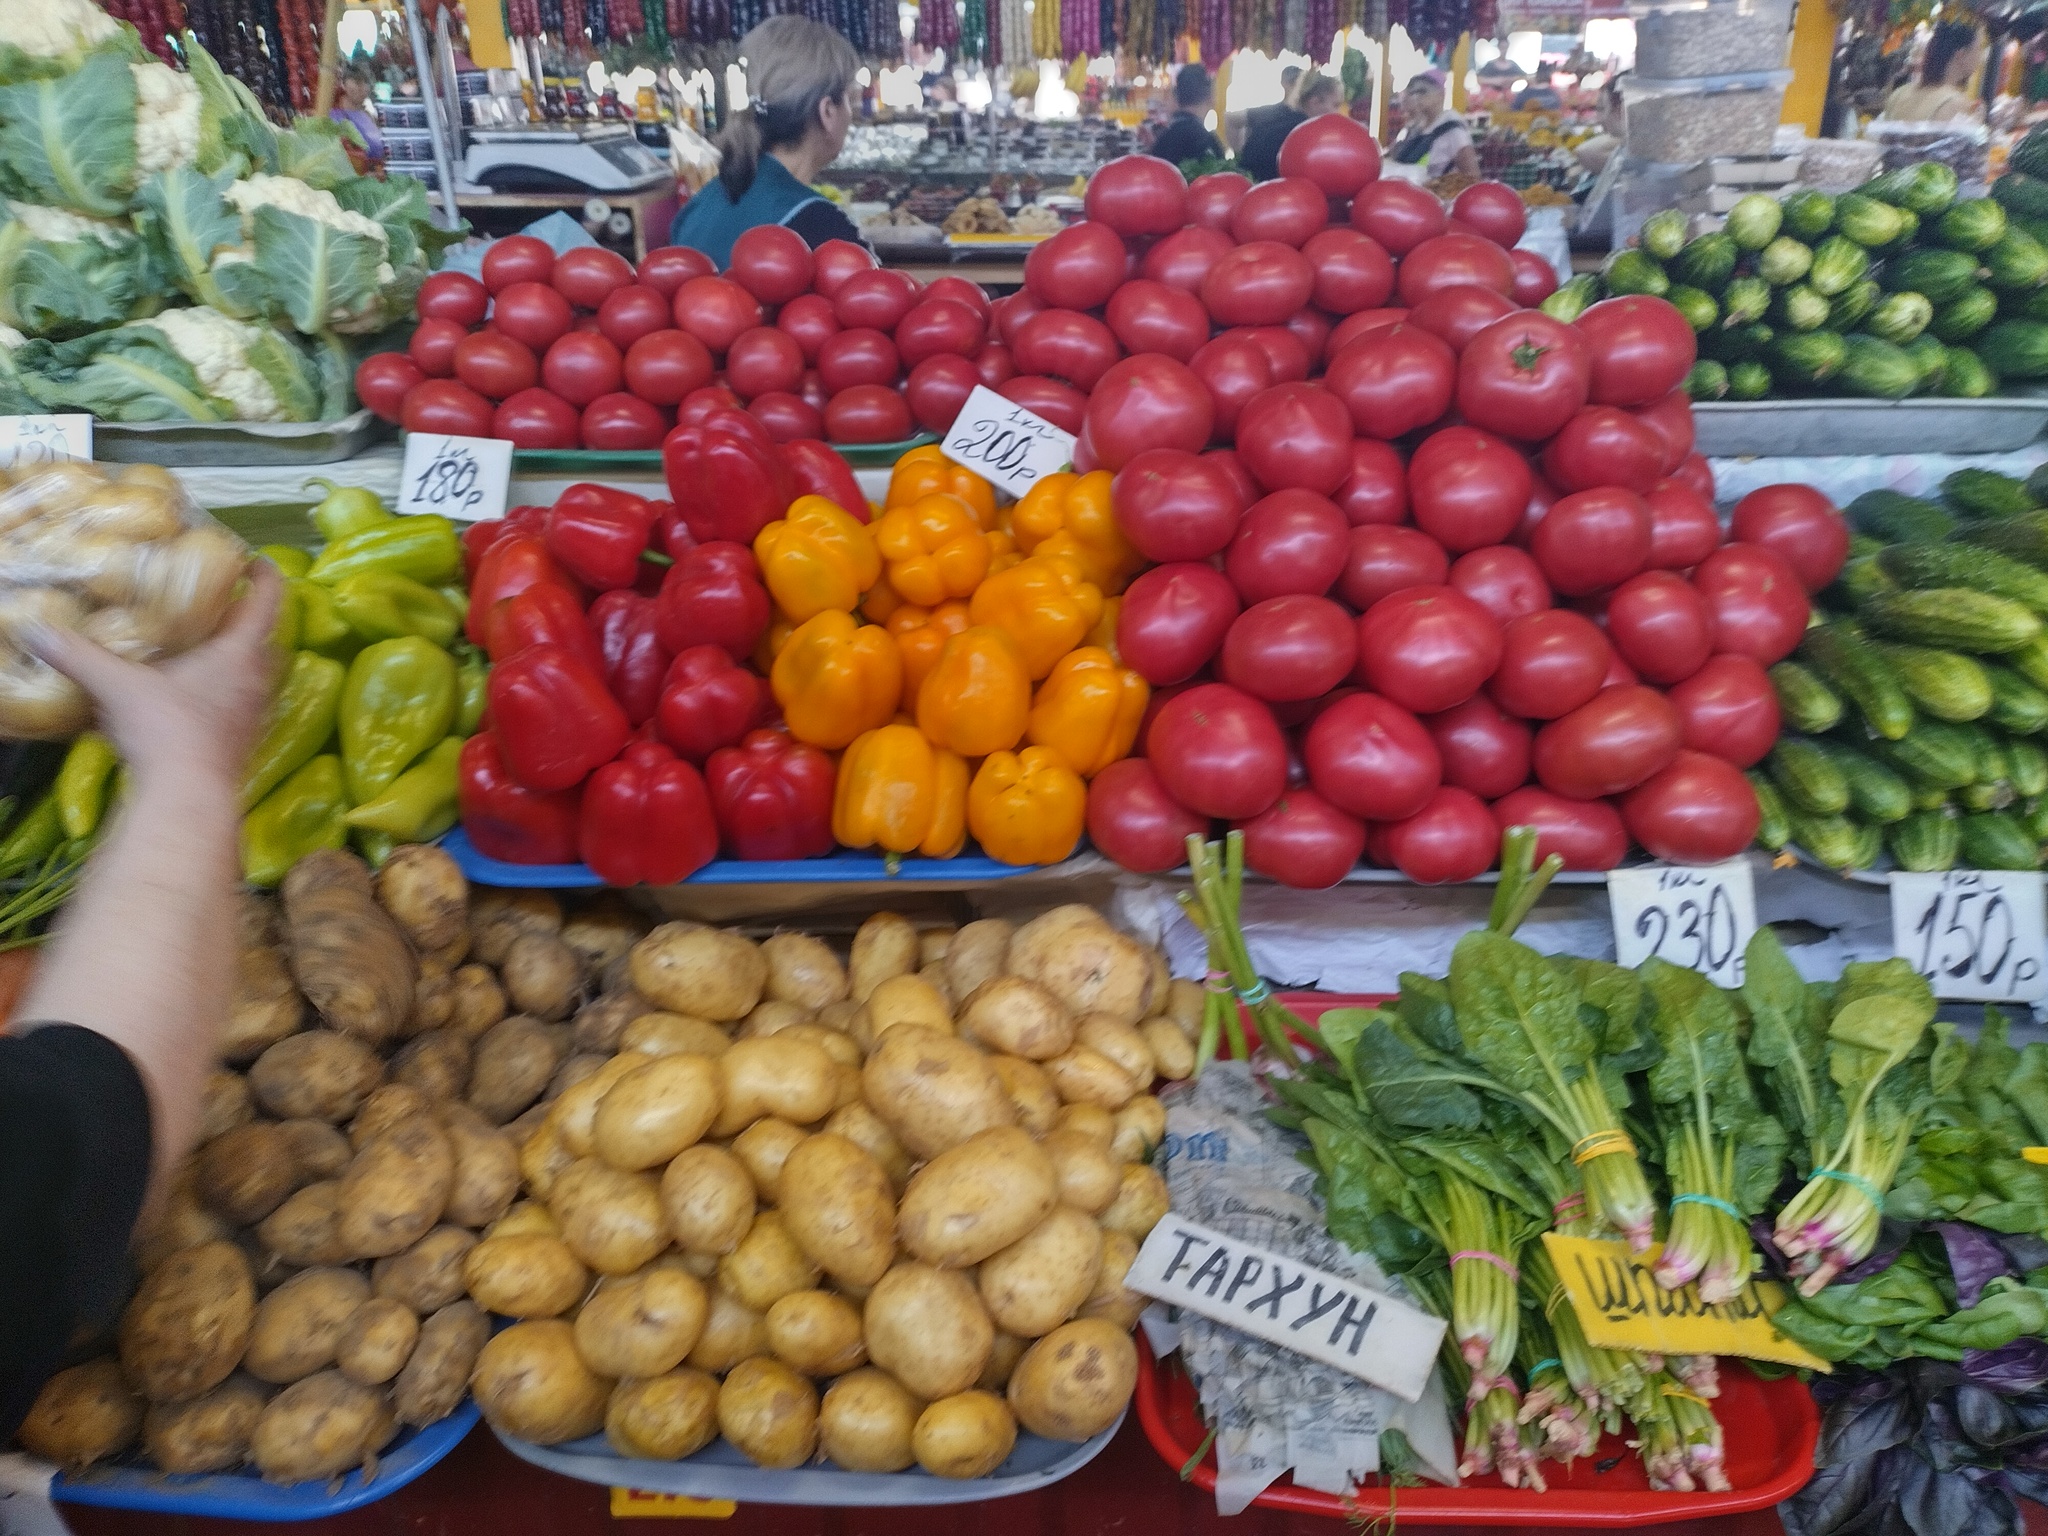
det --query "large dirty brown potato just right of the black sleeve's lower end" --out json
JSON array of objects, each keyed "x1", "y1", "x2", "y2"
[{"x1": 121, "y1": 1243, "x2": 256, "y2": 1403}]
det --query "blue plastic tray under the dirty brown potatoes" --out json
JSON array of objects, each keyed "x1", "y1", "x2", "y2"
[{"x1": 49, "y1": 1399, "x2": 477, "y2": 1520}]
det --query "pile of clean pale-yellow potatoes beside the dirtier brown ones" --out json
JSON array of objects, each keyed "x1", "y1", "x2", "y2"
[{"x1": 463, "y1": 897, "x2": 1202, "y2": 1479}]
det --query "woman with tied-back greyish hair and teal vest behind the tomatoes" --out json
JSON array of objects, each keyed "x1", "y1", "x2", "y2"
[{"x1": 668, "y1": 16, "x2": 860, "y2": 270}]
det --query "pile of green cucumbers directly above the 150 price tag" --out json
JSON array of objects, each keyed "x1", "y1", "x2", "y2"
[{"x1": 1751, "y1": 465, "x2": 2048, "y2": 870}]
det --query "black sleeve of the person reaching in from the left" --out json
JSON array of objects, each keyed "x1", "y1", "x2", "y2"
[{"x1": 0, "y1": 1024, "x2": 150, "y2": 1444}]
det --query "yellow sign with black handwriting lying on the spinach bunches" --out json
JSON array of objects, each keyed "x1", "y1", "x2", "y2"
[{"x1": 1542, "y1": 1233, "x2": 1831, "y2": 1370}]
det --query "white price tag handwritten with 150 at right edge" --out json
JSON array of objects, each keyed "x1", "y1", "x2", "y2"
[{"x1": 1892, "y1": 868, "x2": 2048, "y2": 1004}]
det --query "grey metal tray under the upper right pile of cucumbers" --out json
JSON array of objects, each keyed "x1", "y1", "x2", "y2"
[{"x1": 1692, "y1": 395, "x2": 2048, "y2": 459}]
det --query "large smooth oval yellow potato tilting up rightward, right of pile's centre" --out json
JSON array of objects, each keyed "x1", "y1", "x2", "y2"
[{"x1": 897, "y1": 1126, "x2": 1057, "y2": 1269}]
